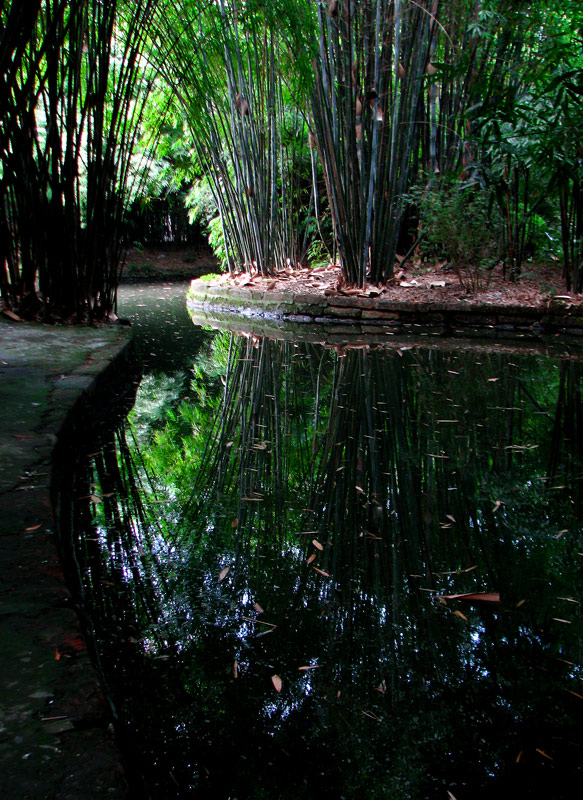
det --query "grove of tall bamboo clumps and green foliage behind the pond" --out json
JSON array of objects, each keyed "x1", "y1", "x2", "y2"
[{"x1": 0, "y1": 0, "x2": 583, "y2": 321}]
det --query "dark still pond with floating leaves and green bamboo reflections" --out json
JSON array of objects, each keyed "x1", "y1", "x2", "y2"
[{"x1": 52, "y1": 286, "x2": 583, "y2": 800}]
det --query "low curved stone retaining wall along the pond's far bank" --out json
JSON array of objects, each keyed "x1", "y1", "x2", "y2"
[{"x1": 187, "y1": 279, "x2": 583, "y2": 338}]
